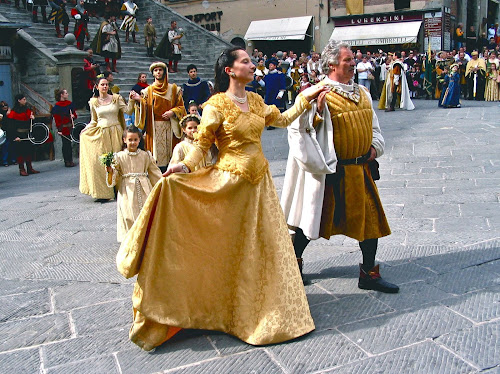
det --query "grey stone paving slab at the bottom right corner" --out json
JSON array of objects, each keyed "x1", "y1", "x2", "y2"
[{"x1": 437, "y1": 321, "x2": 500, "y2": 369}]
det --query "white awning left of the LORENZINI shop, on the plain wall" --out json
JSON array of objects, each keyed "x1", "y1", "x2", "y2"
[{"x1": 245, "y1": 16, "x2": 312, "y2": 40}]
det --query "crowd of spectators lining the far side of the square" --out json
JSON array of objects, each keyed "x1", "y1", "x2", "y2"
[{"x1": 249, "y1": 32, "x2": 500, "y2": 104}]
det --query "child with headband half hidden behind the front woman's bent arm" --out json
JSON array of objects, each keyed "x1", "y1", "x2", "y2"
[{"x1": 170, "y1": 114, "x2": 218, "y2": 171}]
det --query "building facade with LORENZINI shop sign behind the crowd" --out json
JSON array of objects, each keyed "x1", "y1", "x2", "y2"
[{"x1": 162, "y1": 0, "x2": 499, "y2": 52}]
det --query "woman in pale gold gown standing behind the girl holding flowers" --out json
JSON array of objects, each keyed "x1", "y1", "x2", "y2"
[{"x1": 80, "y1": 78, "x2": 134, "y2": 200}]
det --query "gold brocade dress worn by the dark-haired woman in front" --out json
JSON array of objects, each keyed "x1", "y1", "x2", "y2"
[{"x1": 117, "y1": 92, "x2": 314, "y2": 350}]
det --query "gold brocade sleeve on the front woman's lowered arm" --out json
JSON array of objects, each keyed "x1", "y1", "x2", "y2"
[{"x1": 182, "y1": 104, "x2": 223, "y2": 171}]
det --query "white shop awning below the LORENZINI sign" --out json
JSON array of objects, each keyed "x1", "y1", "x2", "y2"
[{"x1": 330, "y1": 21, "x2": 422, "y2": 47}]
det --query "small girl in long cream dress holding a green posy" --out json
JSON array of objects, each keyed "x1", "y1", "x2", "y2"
[{"x1": 106, "y1": 125, "x2": 161, "y2": 242}]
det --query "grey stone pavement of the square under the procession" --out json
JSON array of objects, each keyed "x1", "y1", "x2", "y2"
[{"x1": 0, "y1": 101, "x2": 500, "y2": 374}]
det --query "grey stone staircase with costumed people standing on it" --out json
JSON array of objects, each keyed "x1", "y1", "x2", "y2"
[{"x1": 0, "y1": 0, "x2": 231, "y2": 109}]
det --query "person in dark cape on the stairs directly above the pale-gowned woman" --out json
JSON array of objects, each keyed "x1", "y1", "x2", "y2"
[{"x1": 91, "y1": 15, "x2": 122, "y2": 73}]
